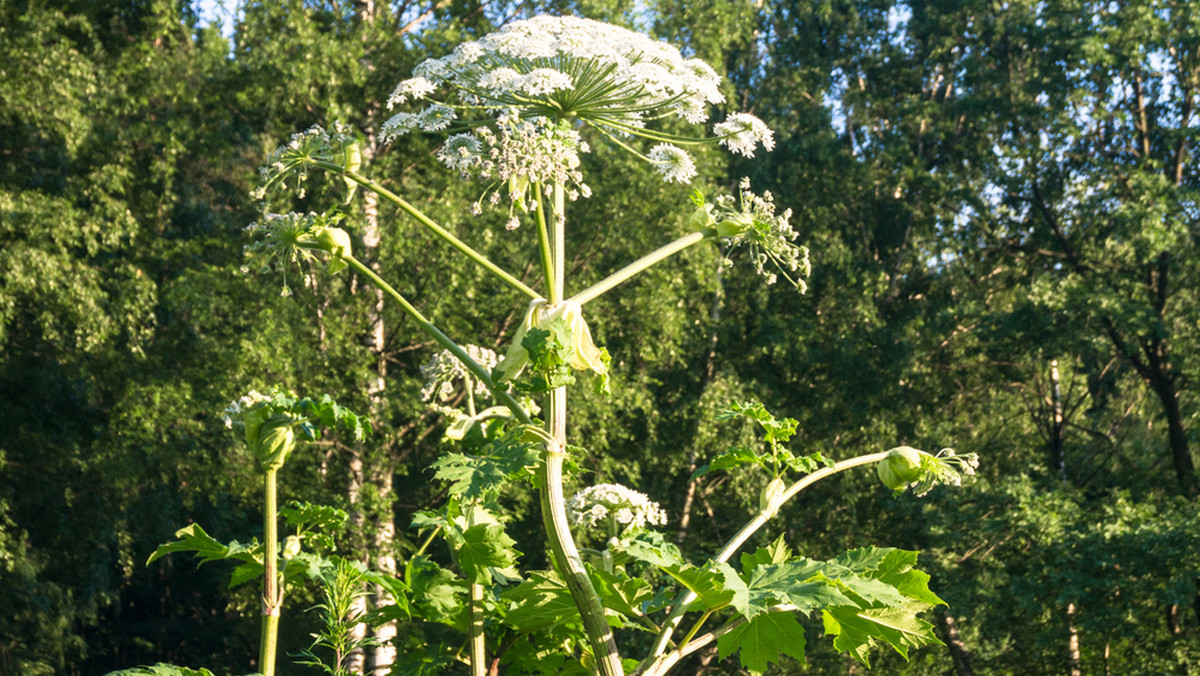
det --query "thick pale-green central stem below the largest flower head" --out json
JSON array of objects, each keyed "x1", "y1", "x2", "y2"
[{"x1": 538, "y1": 184, "x2": 624, "y2": 676}]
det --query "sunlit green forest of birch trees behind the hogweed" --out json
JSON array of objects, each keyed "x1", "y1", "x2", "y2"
[{"x1": 0, "y1": 0, "x2": 1200, "y2": 675}]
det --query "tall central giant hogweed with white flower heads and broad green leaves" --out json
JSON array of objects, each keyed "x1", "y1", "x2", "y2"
[{"x1": 133, "y1": 17, "x2": 976, "y2": 676}]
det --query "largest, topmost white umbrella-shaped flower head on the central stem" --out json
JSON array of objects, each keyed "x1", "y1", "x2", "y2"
[{"x1": 383, "y1": 16, "x2": 774, "y2": 207}]
